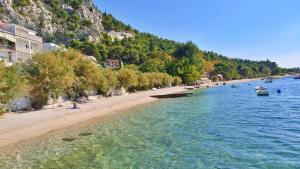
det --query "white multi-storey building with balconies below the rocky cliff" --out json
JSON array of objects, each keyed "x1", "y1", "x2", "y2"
[{"x1": 0, "y1": 22, "x2": 43, "y2": 64}]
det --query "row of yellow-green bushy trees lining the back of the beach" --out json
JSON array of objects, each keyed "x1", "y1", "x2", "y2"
[{"x1": 0, "y1": 49, "x2": 181, "y2": 112}]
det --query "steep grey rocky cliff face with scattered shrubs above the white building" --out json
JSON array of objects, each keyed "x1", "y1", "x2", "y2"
[{"x1": 0, "y1": 0, "x2": 104, "y2": 45}]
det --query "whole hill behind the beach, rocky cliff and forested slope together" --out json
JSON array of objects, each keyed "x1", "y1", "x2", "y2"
[{"x1": 0, "y1": 0, "x2": 288, "y2": 79}]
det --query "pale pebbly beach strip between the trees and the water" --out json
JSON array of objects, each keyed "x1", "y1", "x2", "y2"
[{"x1": 0, "y1": 79, "x2": 259, "y2": 149}]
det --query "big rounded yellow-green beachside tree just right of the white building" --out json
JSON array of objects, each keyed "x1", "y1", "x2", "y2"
[{"x1": 26, "y1": 53, "x2": 75, "y2": 109}]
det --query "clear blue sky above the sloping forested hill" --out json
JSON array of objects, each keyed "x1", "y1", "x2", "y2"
[{"x1": 94, "y1": 0, "x2": 300, "y2": 68}]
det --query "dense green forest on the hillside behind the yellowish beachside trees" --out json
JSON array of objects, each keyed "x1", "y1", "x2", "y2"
[{"x1": 71, "y1": 13, "x2": 283, "y2": 84}]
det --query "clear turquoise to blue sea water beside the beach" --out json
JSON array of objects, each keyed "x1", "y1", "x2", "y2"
[{"x1": 0, "y1": 78, "x2": 300, "y2": 169}]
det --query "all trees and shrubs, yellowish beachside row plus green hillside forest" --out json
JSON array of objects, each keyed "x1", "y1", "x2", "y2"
[{"x1": 0, "y1": 7, "x2": 288, "y2": 115}]
